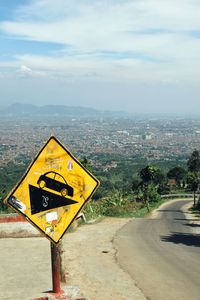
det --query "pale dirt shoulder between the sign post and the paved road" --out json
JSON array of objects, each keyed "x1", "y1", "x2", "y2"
[{"x1": 62, "y1": 218, "x2": 146, "y2": 300}]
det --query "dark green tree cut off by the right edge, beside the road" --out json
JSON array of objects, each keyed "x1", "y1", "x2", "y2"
[{"x1": 187, "y1": 150, "x2": 200, "y2": 207}]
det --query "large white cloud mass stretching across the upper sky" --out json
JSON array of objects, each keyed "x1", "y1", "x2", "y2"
[{"x1": 0, "y1": 0, "x2": 200, "y2": 84}]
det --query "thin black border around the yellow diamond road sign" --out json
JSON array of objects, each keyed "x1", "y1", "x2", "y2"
[{"x1": 4, "y1": 135, "x2": 100, "y2": 244}]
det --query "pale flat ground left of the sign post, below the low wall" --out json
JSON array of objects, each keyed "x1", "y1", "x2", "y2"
[{"x1": 0, "y1": 237, "x2": 52, "y2": 300}]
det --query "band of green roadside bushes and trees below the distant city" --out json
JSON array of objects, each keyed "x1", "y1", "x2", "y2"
[{"x1": 0, "y1": 150, "x2": 200, "y2": 220}]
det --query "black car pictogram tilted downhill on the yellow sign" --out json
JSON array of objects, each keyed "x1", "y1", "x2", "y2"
[{"x1": 37, "y1": 171, "x2": 74, "y2": 197}]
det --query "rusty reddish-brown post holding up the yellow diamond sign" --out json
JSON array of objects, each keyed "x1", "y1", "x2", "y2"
[{"x1": 51, "y1": 242, "x2": 61, "y2": 294}]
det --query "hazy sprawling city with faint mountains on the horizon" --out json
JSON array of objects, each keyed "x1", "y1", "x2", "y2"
[{"x1": 0, "y1": 105, "x2": 200, "y2": 170}]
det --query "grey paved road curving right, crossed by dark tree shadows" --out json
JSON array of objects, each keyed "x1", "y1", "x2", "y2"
[{"x1": 114, "y1": 200, "x2": 200, "y2": 300}]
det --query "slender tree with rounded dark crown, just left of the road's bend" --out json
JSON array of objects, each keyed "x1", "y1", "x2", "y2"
[{"x1": 139, "y1": 165, "x2": 159, "y2": 212}]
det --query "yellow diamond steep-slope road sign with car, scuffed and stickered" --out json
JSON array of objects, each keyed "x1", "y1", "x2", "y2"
[{"x1": 6, "y1": 136, "x2": 99, "y2": 243}]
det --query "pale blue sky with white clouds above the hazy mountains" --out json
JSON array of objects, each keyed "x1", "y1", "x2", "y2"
[{"x1": 0, "y1": 0, "x2": 200, "y2": 114}]
